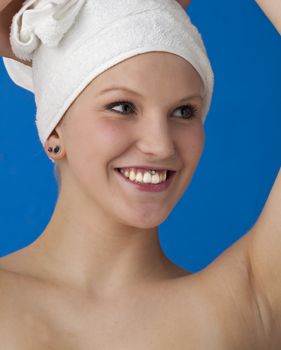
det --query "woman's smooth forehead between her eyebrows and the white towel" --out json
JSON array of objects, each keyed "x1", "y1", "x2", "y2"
[{"x1": 84, "y1": 52, "x2": 203, "y2": 92}]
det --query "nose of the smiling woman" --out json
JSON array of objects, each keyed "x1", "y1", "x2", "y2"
[{"x1": 135, "y1": 115, "x2": 176, "y2": 160}]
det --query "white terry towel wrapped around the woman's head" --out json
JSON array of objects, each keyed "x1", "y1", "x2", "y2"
[{"x1": 3, "y1": 0, "x2": 214, "y2": 149}]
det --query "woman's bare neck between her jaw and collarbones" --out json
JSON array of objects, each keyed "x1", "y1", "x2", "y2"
[{"x1": 27, "y1": 182, "x2": 180, "y2": 295}]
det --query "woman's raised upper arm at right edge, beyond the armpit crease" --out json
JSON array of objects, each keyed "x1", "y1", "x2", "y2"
[{"x1": 248, "y1": 168, "x2": 281, "y2": 349}]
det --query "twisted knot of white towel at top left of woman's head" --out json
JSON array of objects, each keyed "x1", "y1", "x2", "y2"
[{"x1": 10, "y1": 0, "x2": 86, "y2": 61}]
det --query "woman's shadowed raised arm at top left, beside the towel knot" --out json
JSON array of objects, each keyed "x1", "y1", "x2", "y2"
[{"x1": 0, "y1": 0, "x2": 32, "y2": 67}]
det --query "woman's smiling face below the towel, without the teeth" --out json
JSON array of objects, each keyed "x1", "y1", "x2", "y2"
[{"x1": 54, "y1": 52, "x2": 204, "y2": 228}]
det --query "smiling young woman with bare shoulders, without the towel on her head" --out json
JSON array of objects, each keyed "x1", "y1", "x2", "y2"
[{"x1": 0, "y1": 0, "x2": 281, "y2": 350}]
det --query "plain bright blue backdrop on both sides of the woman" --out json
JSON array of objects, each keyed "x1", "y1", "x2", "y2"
[{"x1": 0, "y1": 0, "x2": 281, "y2": 272}]
